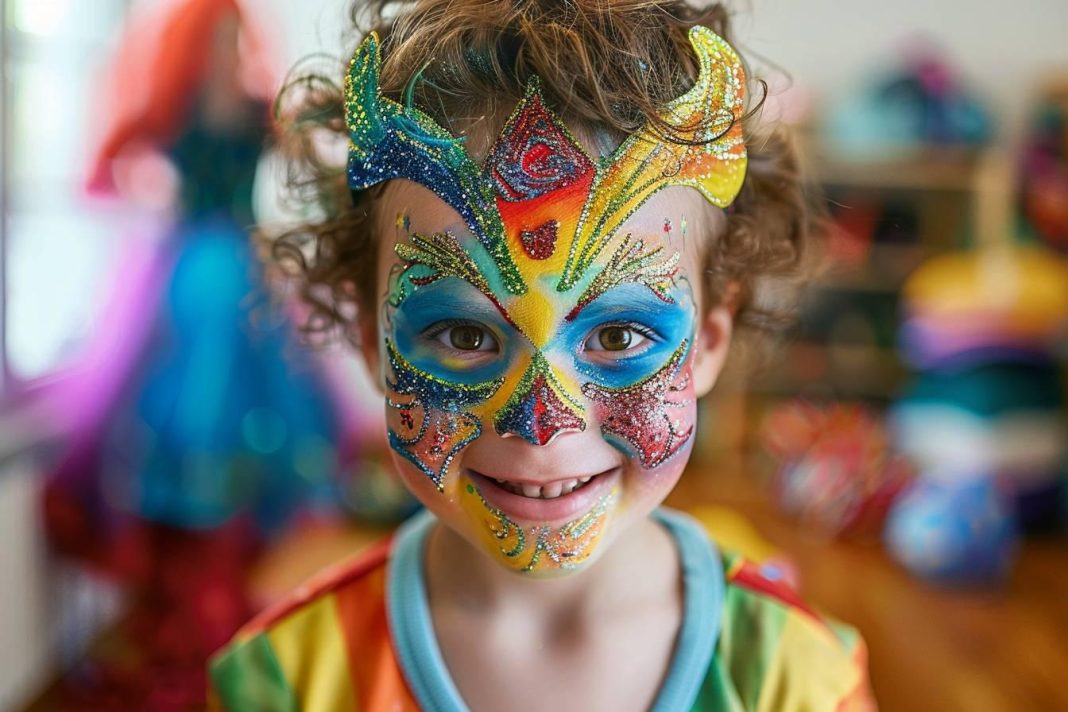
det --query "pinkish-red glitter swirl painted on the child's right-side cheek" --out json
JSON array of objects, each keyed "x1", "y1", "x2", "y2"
[{"x1": 582, "y1": 342, "x2": 694, "y2": 470}]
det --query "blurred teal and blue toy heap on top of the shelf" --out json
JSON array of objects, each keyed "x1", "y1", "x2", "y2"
[{"x1": 823, "y1": 42, "x2": 992, "y2": 159}]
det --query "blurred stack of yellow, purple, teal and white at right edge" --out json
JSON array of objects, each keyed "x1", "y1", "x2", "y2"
[{"x1": 891, "y1": 247, "x2": 1068, "y2": 532}]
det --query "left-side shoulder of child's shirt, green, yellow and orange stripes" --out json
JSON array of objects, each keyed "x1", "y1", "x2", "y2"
[{"x1": 208, "y1": 539, "x2": 392, "y2": 710}]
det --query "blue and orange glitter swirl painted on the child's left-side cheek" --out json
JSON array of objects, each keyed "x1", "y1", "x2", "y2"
[{"x1": 386, "y1": 341, "x2": 504, "y2": 491}]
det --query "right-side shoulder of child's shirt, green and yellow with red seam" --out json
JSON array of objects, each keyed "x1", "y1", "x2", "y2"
[{"x1": 713, "y1": 554, "x2": 875, "y2": 711}]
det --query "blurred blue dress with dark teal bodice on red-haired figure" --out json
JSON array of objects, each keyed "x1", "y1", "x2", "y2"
[{"x1": 97, "y1": 105, "x2": 337, "y2": 532}]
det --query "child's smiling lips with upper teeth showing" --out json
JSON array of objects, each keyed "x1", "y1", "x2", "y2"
[{"x1": 466, "y1": 468, "x2": 619, "y2": 524}]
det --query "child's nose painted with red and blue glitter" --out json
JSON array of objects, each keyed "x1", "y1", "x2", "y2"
[{"x1": 493, "y1": 353, "x2": 586, "y2": 445}]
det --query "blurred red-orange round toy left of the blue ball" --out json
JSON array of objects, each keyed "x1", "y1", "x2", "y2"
[{"x1": 764, "y1": 401, "x2": 911, "y2": 537}]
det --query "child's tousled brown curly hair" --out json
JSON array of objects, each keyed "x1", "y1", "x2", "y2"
[{"x1": 267, "y1": 0, "x2": 819, "y2": 341}]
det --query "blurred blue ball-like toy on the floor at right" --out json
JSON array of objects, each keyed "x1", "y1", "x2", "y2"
[{"x1": 886, "y1": 474, "x2": 1016, "y2": 584}]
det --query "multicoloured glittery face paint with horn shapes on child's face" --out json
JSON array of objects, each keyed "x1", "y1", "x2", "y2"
[{"x1": 346, "y1": 28, "x2": 745, "y2": 573}]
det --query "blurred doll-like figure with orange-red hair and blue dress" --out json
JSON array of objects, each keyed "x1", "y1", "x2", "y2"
[{"x1": 45, "y1": 0, "x2": 337, "y2": 709}]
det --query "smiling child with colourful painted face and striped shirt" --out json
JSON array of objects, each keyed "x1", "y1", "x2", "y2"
[{"x1": 211, "y1": 0, "x2": 871, "y2": 711}]
